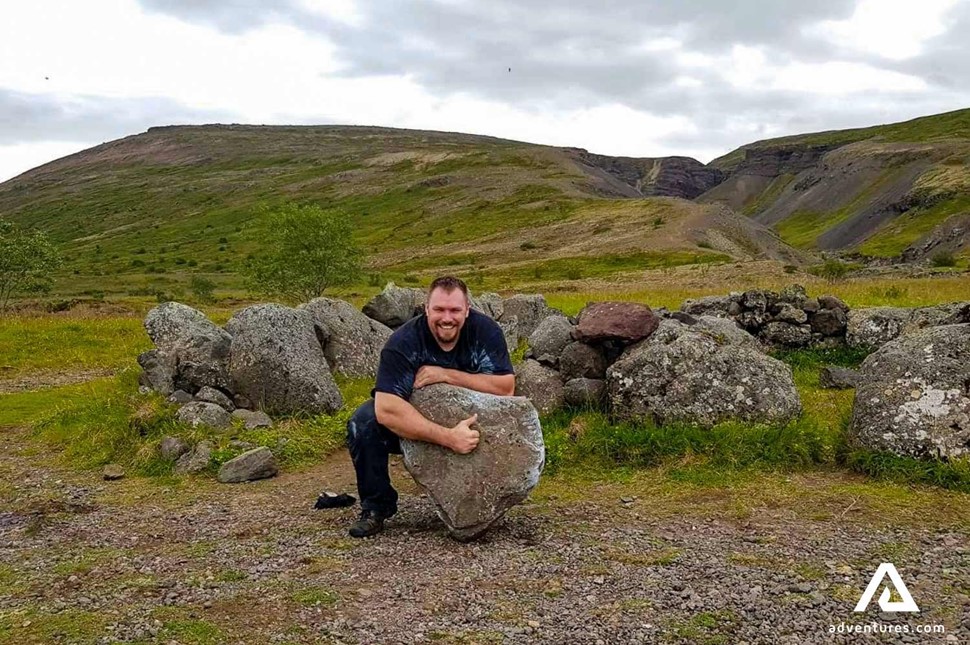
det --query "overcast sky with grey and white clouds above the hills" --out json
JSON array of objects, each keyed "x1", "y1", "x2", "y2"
[{"x1": 0, "y1": 0, "x2": 970, "y2": 181}]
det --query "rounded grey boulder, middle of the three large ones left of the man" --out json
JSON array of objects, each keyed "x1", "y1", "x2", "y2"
[{"x1": 226, "y1": 304, "x2": 343, "y2": 414}]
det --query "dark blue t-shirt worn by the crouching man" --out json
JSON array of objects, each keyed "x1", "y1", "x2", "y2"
[{"x1": 371, "y1": 309, "x2": 514, "y2": 401}]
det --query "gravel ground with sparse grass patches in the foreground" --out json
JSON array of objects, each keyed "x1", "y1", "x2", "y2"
[{"x1": 0, "y1": 429, "x2": 970, "y2": 643}]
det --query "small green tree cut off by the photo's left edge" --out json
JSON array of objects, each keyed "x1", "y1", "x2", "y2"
[{"x1": 0, "y1": 219, "x2": 61, "y2": 311}]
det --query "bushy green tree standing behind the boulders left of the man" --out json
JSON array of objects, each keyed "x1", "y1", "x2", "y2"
[{"x1": 243, "y1": 204, "x2": 361, "y2": 301}]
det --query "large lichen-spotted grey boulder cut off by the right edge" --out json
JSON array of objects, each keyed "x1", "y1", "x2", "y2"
[{"x1": 850, "y1": 324, "x2": 970, "y2": 458}]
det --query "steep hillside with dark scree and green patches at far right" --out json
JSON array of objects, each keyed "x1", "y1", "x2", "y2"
[{"x1": 698, "y1": 110, "x2": 970, "y2": 260}]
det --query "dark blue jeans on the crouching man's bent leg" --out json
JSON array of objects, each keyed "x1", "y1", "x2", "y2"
[{"x1": 347, "y1": 399, "x2": 401, "y2": 517}]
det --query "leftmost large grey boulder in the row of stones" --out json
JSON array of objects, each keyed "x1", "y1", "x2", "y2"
[{"x1": 144, "y1": 302, "x2": 232, "y2": 394}]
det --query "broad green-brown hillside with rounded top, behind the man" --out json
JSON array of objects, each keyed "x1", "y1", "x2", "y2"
[{"x1": 0, "y1": 125, "x2": 806, "y2": 293}]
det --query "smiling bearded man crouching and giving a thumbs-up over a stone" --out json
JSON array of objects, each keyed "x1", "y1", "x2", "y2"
[{"x1": 347, "y1": 277, "x2": 515, "y2": 537}]
